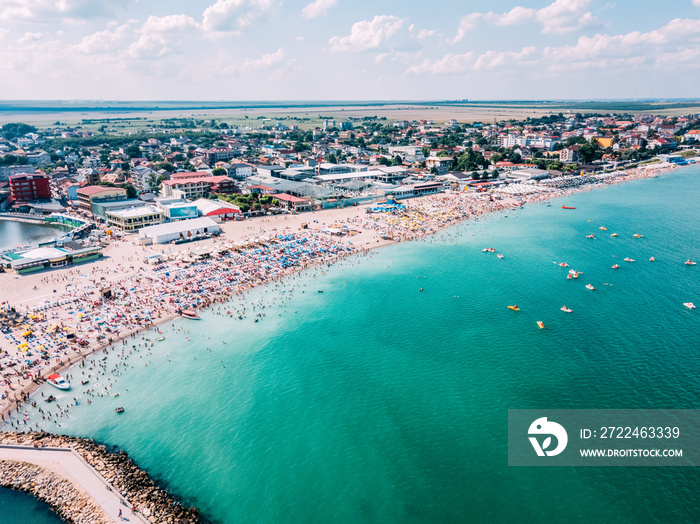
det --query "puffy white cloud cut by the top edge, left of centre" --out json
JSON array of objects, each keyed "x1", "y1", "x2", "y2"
[{"x1": 202, "y1": 0, "x2": 279, "y2": 33}]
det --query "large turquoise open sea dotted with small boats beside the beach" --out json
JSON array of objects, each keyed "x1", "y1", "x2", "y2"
[{"x1": 1, "y1": 167, "x2": 700, "y2": 523}]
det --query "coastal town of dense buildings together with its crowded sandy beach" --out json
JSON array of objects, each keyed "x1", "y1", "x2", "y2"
[{"x1": 0, "y1": 108, "x2": 700, "y2": 511}]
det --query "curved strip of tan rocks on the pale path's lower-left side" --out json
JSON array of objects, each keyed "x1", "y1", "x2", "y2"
[{"x1": 0, "y1": 460, "x2": 112, "y2": 524}]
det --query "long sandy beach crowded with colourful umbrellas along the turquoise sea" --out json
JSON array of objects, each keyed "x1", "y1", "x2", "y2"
[{"x1": 0, "y1": 164, "x2": 673, "y2": 420}]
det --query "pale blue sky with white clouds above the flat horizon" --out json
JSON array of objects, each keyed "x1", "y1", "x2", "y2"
[{"x1": 0, "y1": 0, "x2": 700, "y2": 101}]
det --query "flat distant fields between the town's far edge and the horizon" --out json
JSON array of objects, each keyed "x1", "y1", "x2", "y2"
[{"x1": 0, "y1": 100, "x2": 700, "y2": 133}]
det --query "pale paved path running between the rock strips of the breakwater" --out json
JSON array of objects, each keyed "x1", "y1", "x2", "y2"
[{"x1": 0, "y1": 445, "x2": 148, "y2": 524}]
